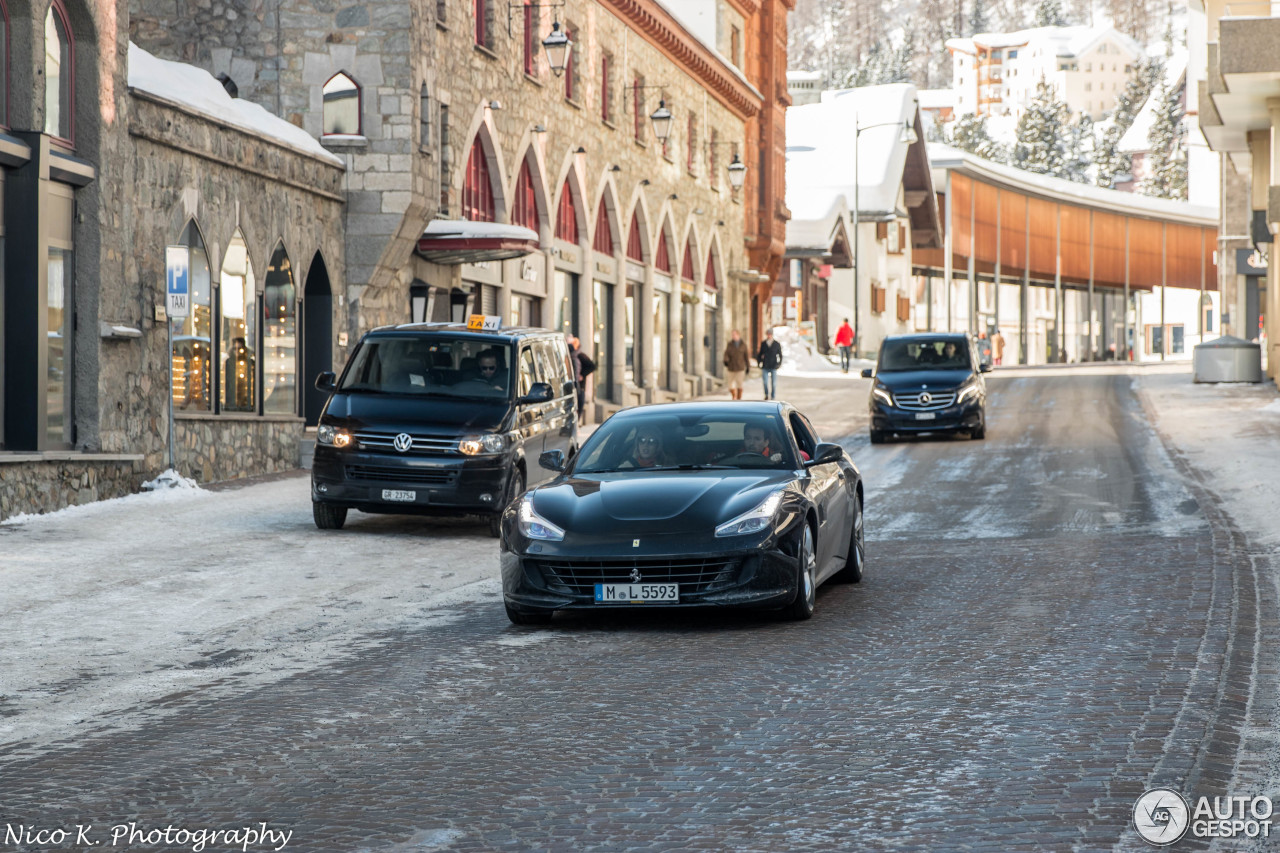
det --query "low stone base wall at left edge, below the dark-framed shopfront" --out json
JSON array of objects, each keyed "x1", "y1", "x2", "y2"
[{"x1": 0, "y1": 453, "x2": 146, "y2": 520}]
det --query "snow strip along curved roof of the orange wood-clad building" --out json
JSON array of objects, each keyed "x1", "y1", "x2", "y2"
[{"x1": 929, "y1": 142, "x2": 1217, "y2": 220}]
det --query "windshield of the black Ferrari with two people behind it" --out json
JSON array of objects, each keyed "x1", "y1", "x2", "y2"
[{"x1": 573, "y1": 410, "x2": 796, "y2": 474}]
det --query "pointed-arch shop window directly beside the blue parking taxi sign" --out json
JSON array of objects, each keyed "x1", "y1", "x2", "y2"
[{"x1": 169, "y1": 222, "x2": 214, "y2": 411}]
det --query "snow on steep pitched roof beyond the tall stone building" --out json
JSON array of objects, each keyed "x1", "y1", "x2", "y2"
[{"x1": 786, "y1": 83, "x2": 916, "y2": 247}]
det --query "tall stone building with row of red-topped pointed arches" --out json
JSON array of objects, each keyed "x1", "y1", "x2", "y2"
[{"x1": 131, "y1": 0, "x2": 787, "y2": 414}]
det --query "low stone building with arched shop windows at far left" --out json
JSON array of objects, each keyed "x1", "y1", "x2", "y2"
[{"x1": 0, "y1": 0, "x2": 344, "y2": 517}]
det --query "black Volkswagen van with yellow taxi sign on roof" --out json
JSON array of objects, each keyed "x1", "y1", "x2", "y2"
[{"x1": 311, "y1": 323, "x2": 577, "y2": 535}]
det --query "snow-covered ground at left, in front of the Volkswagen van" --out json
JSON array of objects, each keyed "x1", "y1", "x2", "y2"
[{"x1": 0, "y1": 476, "x2": 500, "y2": 747}]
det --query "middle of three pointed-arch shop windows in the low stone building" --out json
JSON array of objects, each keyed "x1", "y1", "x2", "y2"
[{"x1": 218, "y1": 231, "x2": 257, "y2": 411}]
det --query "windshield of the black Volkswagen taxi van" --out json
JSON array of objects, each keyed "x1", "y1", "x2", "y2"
[{"x1": 338, "y1": 334, "x2": 511, "y2": 398}]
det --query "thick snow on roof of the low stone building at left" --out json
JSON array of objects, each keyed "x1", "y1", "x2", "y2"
[{"x1": 129, "y1": 41, "x2": 346, "y2": 167}]
